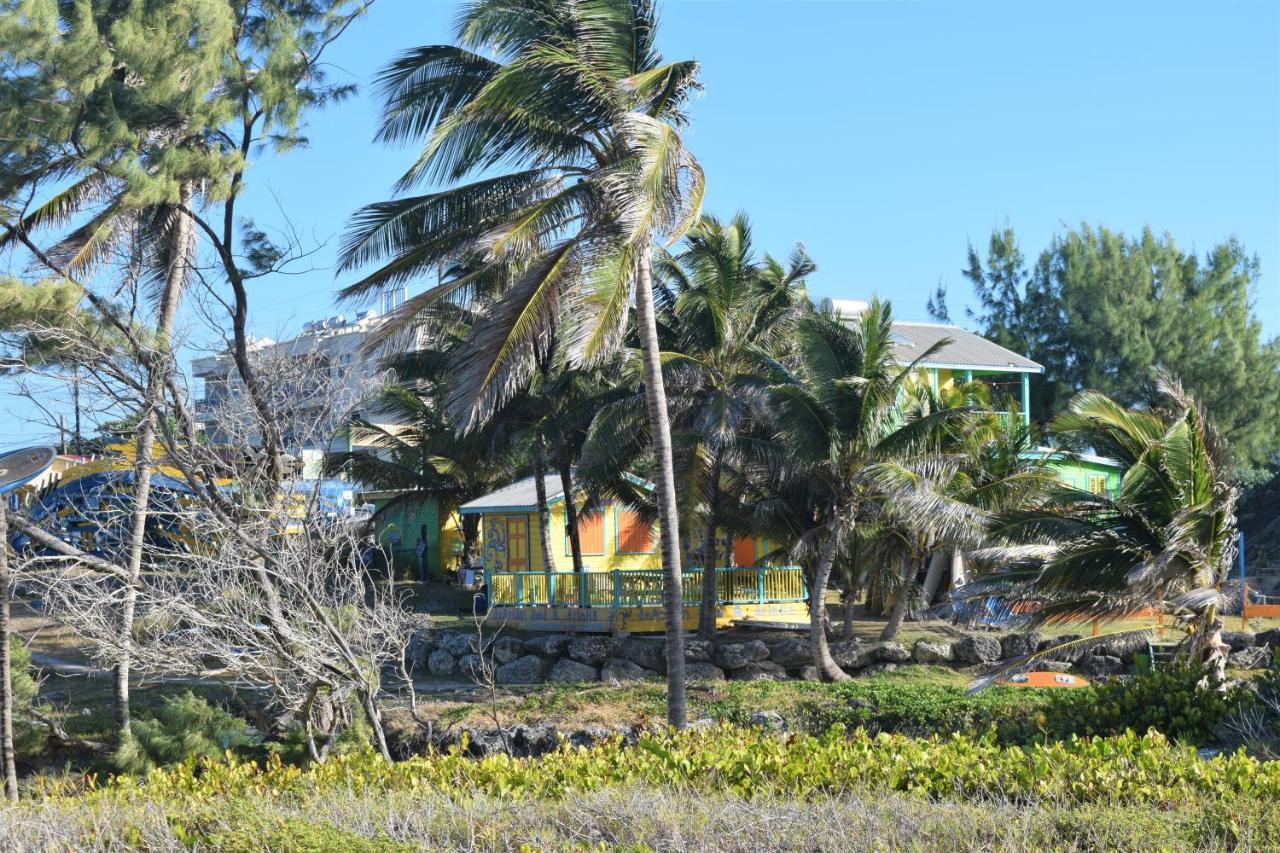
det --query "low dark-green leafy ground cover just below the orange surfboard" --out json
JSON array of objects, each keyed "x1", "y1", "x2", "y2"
[{"x1": 797, "y1": 667, "x2": 1247, "y2": 744}]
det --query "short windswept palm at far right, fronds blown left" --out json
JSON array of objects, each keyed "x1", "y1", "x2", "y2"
[{"x1": 974, "y1": 378, "x2": 1238, "y2": 688}]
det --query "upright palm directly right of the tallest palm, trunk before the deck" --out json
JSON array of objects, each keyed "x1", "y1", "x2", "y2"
[{"x1": 655, "y1": 214, "x2": 815, "y2": 639}]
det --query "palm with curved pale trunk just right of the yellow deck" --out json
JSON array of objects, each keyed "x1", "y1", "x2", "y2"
[{"x1": 771, "y1": 300, "x2": 969, "y2": 680}]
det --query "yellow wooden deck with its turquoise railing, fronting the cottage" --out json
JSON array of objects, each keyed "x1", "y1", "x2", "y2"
[{"x1": 486, "y1": 566, "x2": 809, "y2": 634}]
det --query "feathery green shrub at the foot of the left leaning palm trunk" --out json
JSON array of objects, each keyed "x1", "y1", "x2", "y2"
[{"x1": 114, "y1": 690, "x2": 261, "y2": 775}]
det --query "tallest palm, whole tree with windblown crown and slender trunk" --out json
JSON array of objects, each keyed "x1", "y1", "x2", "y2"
[{"x1": 342, "y1": 0, "x2": 703, "y2": 726}]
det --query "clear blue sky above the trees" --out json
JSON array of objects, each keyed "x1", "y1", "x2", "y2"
[{"x1": 0, "y1": 0, "x2": 1280, "y2": 441}]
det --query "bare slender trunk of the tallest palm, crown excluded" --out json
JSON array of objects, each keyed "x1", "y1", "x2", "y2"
[{"x1": 636, "y1": 240, "x2": 685, "y2": 729}]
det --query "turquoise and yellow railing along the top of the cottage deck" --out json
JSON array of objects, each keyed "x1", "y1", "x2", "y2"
[{"x1": 485, "y1": 566, "x2": 809, "y2": 610}]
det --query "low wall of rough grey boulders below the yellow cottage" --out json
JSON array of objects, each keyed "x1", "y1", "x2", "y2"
[{"x1": 411, "y1": 629, "x2": 1280, "y2": 684}]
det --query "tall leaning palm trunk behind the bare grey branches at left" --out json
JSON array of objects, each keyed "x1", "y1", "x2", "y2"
[{"x1": 114, "y1": 183, "x2": 195, "y2": 735}]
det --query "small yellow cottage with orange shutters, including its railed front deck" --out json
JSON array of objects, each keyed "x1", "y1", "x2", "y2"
[{"x1": 458, "y1": 474, "x2": 808, "y2": 633}]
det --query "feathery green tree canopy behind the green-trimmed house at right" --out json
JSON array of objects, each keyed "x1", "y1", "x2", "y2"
[{"x1": 964, "y1": 224, "x2": 1280, "y2": 464}]
